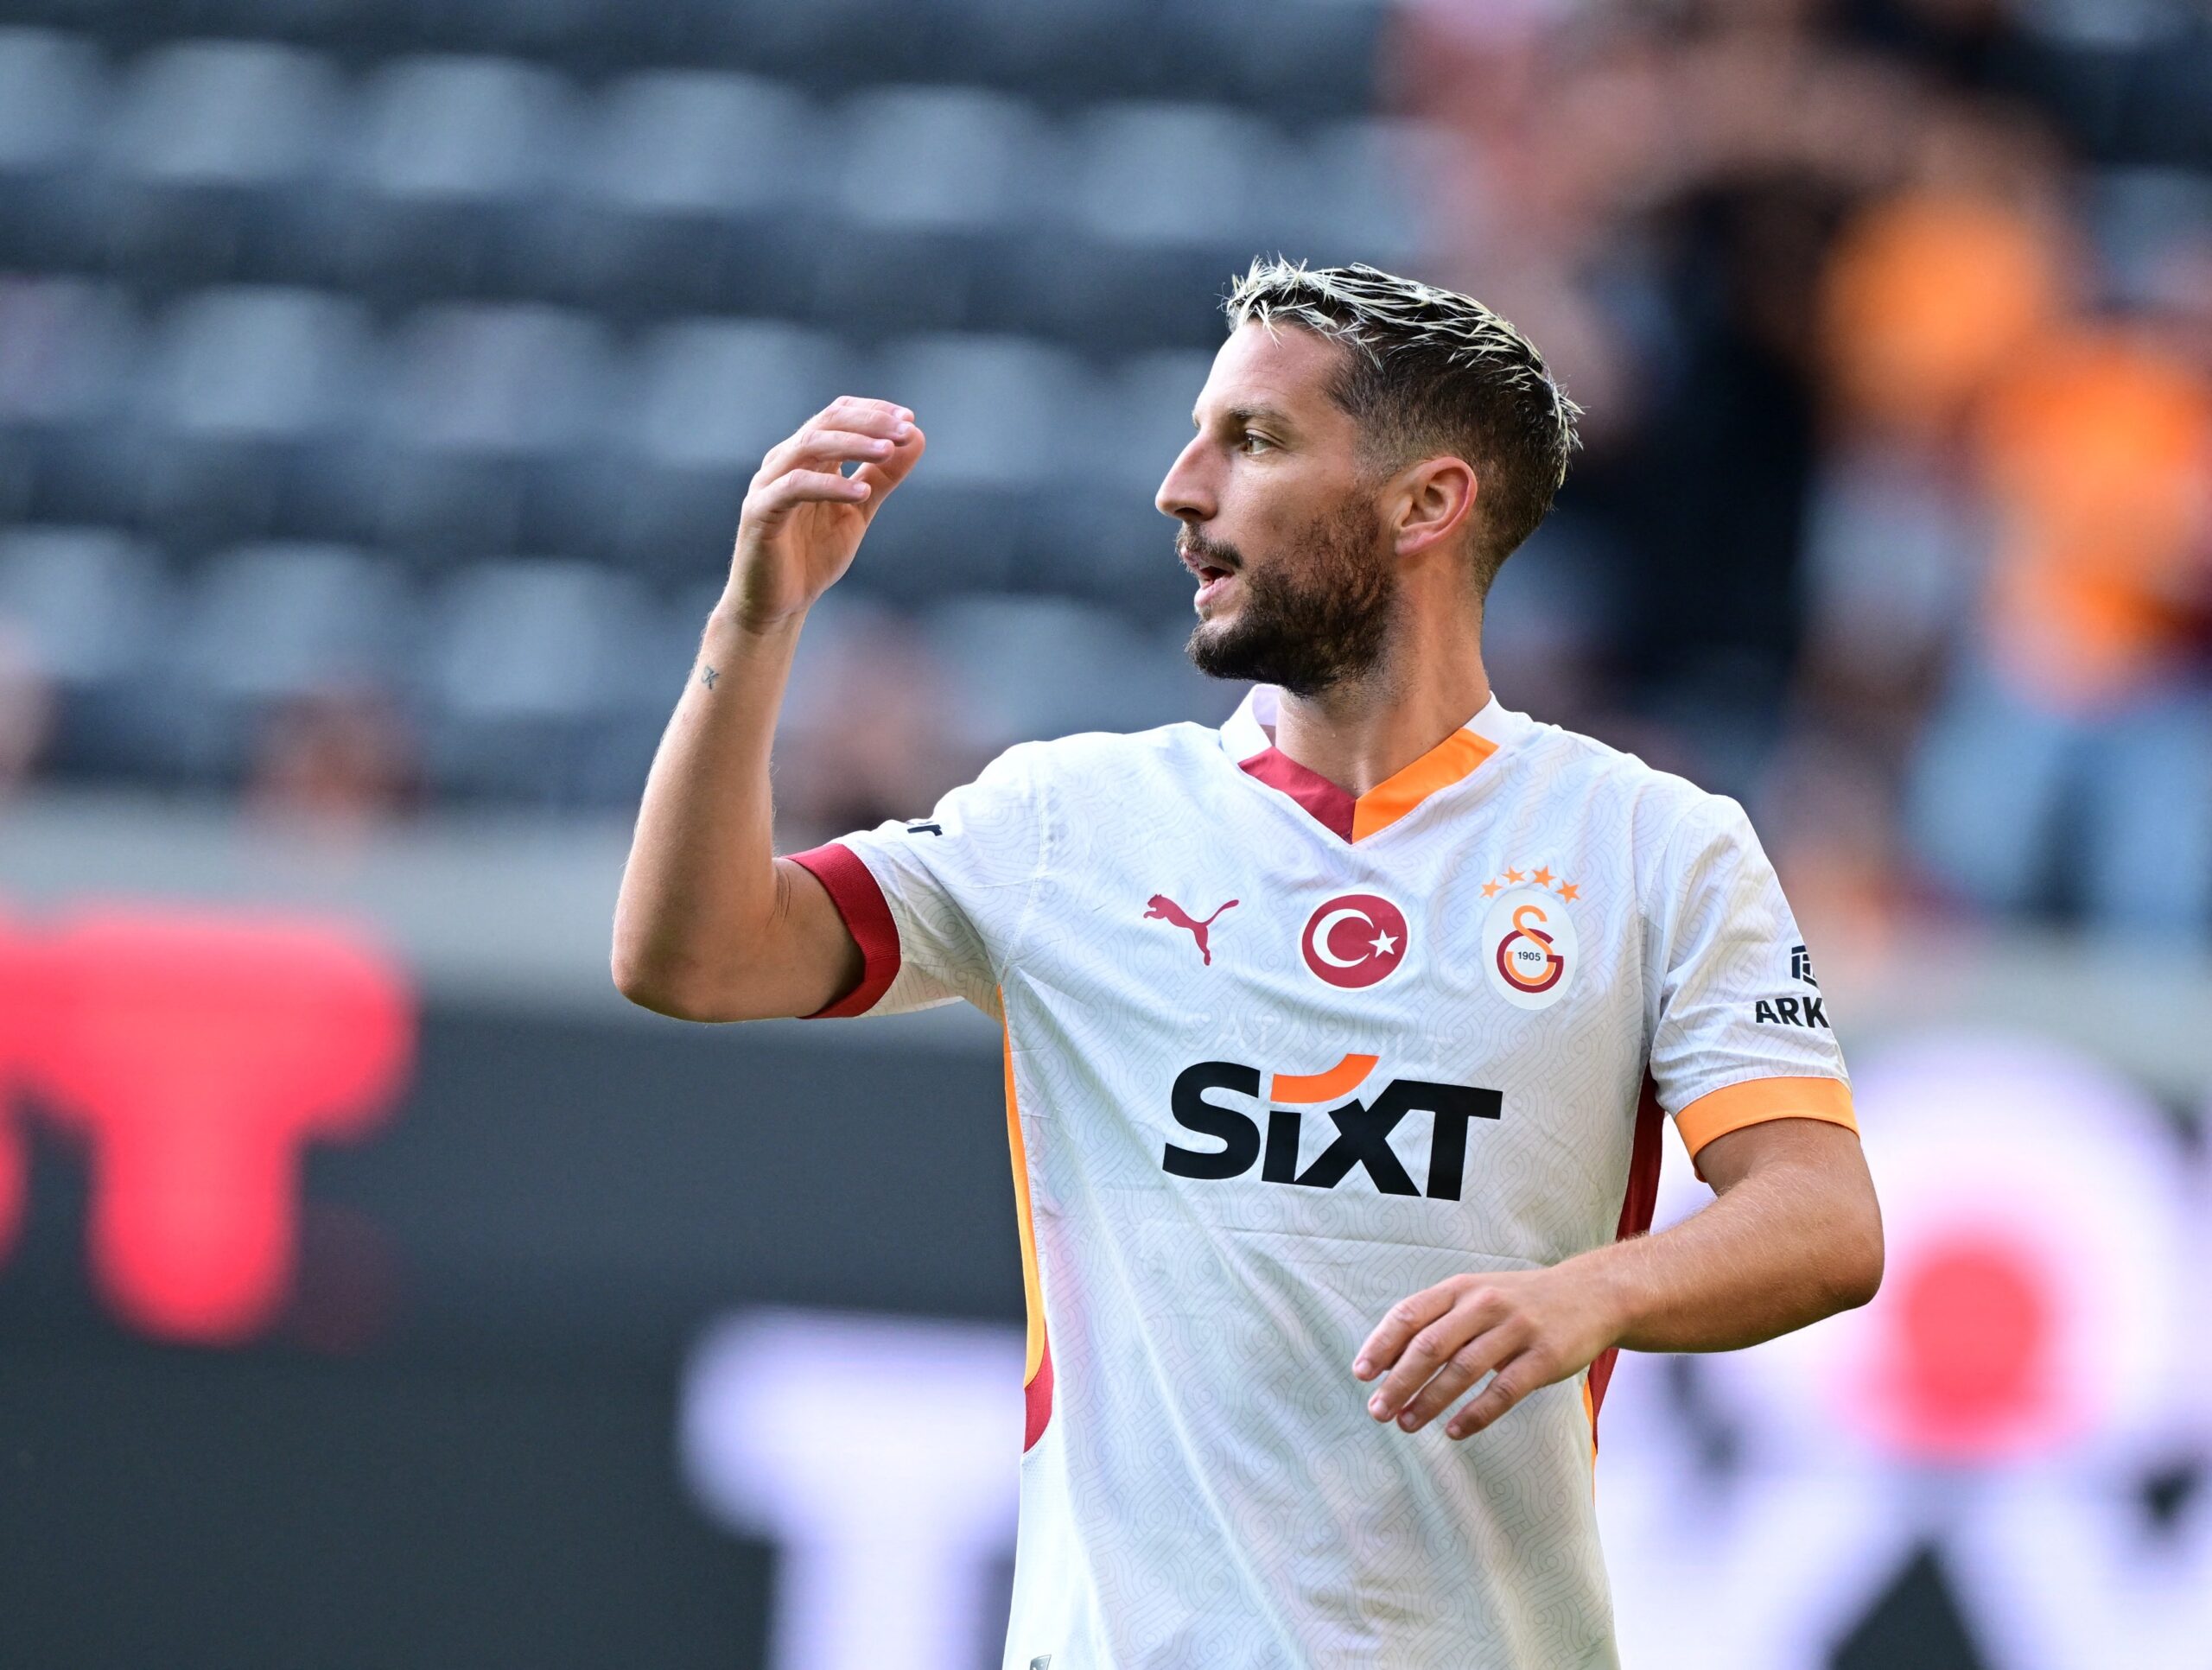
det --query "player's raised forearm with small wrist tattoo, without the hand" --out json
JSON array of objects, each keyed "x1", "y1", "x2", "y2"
[{"x1": 615, "y1": 600, "x2": 803, "y2": 1013}]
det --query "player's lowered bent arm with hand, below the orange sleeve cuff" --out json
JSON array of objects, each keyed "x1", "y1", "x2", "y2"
[{"x1": 1351, "y1": 1119, "x2": 1883, "y2": 1438}]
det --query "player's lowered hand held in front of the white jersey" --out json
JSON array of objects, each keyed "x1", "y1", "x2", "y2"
[{"x1": 1351, "y1": 1259, "x2": 1619, "y2": 1438}]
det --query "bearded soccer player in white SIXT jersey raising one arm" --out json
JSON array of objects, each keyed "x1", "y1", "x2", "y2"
[{"x1": 615, "y1": 261, "x2": 1883, "y2": 1670}]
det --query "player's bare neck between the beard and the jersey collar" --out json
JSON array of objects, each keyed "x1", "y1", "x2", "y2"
[{"x1": 1274, "y1": 588, "x2": 1491, "y2": 794}]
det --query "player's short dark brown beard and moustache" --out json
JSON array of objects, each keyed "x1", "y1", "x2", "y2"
[{"x1": 1177, "y1": 505, "x2": 1398, "y2": 696}]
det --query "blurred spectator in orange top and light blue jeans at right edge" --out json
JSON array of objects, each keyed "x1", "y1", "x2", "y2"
[{"x1": 1913, "y1": 327, "x2": 2212, "y2": 936}]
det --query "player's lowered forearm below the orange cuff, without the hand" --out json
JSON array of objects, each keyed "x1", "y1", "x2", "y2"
[{"x1": 1560, "y1": 1133, "x2": 1883, "y2": 1351}]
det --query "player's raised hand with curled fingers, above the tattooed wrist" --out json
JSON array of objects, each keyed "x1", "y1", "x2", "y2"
[{"x1": 728, "y1": 394, "x2": 927, "y2": 632}]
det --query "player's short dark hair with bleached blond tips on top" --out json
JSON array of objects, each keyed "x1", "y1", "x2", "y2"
[{"x1": 1221, "y1": 257, "x2": 1581, "y2": 588}]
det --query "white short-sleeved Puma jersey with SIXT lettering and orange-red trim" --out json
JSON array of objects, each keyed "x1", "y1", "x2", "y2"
[{"x1": 798, "y1": 688, "x2": 1853, "y2": 1670}]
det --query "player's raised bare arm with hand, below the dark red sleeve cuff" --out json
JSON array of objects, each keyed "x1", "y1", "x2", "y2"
[{"x1": 613, "y1": 398, "x2": 925, "y2": 1019}]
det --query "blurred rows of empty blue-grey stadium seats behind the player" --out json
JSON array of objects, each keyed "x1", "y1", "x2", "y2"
[{"x1": 0, "y1": 0, "x2": 1421, "y2": 805}]
